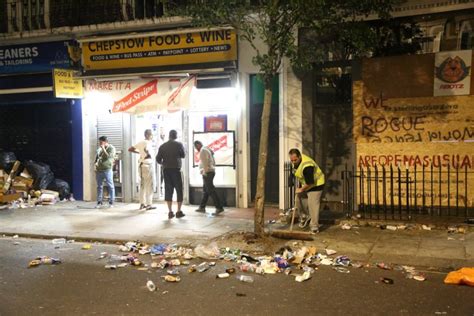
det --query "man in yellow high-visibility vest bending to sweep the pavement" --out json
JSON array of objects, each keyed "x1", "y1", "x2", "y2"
[{"x1": 289, "y1": 148, "x2": 325, "y2": 233}]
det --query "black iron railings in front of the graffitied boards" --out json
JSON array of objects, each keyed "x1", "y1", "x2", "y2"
[{"x1": 341, "y1": 165, "x2": 474, "y2": 220}]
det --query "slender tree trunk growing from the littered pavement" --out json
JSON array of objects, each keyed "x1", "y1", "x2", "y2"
[{"x1": 254, "y1": 87, "x2": 272, "y2": 237}]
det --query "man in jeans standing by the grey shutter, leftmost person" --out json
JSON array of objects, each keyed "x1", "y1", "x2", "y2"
[{"x1": 94, "y1": 136, "x2": 115, "y2": 208}]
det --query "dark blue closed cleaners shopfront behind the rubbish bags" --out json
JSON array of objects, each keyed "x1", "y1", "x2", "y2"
[{"x1": 0, "y1": 41, "x2": 83, "y2": 199}]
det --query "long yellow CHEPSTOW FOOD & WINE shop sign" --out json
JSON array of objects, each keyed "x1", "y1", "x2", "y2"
[{"x1": 82, "y1": 29, "x2": 237, "y2": 71}]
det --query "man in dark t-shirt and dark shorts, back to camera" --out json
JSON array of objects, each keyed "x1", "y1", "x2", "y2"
[{"x1": 156, "y1": 130, "x2": 185, "y2": 219}]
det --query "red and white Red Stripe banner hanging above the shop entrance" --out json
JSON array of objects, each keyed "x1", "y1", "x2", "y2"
[{"x1": 85, "y1": 76, "x2": 196, "y2": 114}]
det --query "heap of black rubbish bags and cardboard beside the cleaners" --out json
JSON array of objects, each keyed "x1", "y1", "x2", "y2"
[{"x1": 0, "y1": 152, "x2": 71, "y2": 209}]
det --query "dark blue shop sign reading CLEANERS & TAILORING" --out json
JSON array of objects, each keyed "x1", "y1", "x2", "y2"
[{"x1": 0, "y1": 41, "x2": 78, "y2": 75}]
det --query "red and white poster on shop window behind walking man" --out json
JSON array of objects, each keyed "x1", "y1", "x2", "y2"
[{"x1": 193, "y1": 131, "x2": 235, "y2": 167}]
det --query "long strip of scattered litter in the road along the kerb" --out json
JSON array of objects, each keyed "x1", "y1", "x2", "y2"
[{"x1": 94, "y1": 241, "x2": 432, "y2": 284}]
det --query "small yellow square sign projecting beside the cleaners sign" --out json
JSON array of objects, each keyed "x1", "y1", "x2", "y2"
[{"x1": 53, "y1": 69, "x2": 83, "y2": 99}]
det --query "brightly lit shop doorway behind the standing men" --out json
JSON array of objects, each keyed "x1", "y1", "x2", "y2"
[{"x1": 131, "y1": 111, "x2": 187, "y2": 201}]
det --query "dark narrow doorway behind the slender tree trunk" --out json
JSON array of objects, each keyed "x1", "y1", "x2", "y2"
[{"x1": 249, "y1": 75, "x2": 280, "y2": 204}]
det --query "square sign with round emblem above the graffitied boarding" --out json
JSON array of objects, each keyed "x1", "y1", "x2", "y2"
[{"x1": 434, "y1": 50, "x2": 472, "y2": 96}]
